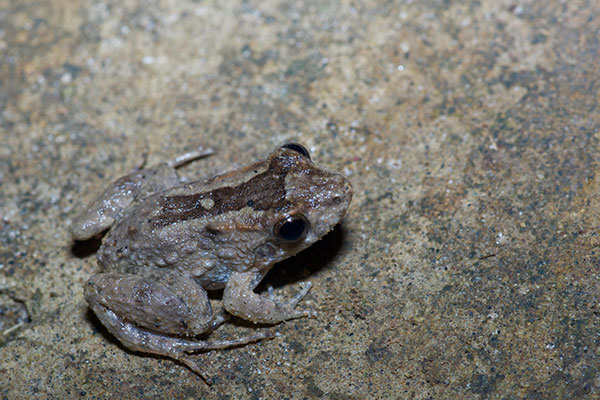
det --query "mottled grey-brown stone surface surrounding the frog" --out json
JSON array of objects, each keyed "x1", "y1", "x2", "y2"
[{"x1": 0, "y1": 0, "x2": 600, "y2": 400}]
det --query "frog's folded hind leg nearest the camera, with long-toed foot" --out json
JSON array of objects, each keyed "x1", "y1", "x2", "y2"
[{"x1": 85, "y1": 272, "x2": 273, "y2": 382}]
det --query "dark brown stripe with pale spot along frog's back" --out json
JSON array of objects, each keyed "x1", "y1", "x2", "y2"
[{"x1": 152, "y1": 158, "x2": 290, "y2": 227}]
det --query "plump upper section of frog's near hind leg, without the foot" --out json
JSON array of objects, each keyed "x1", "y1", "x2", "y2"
[{"x1": 85, "y1": 273, "x2": 213, "y2": 336}]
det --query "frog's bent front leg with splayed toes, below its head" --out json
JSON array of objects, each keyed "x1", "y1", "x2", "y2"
[{"x1": 223, "y1": 272, "x2": 315, "y2": 324}]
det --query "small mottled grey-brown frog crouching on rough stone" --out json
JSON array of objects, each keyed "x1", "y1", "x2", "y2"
[{"x1": 69, "y1": 142, "x2": 353, "y2": 383}]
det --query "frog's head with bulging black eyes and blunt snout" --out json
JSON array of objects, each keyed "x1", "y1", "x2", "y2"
[{"x1": 252, "y1": 143, "x2": 352, "y2": 267}]
